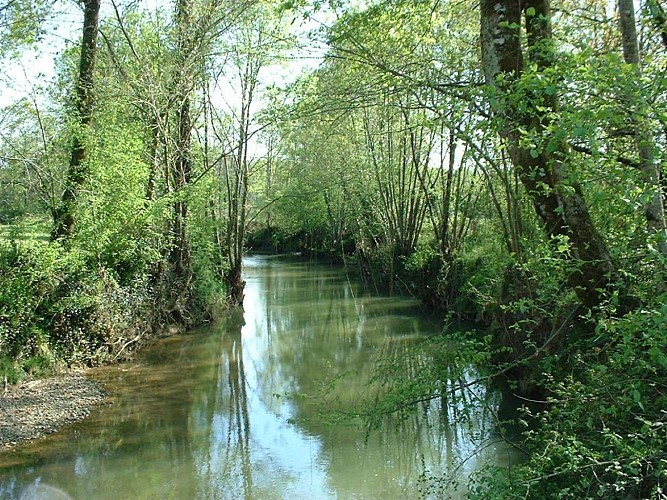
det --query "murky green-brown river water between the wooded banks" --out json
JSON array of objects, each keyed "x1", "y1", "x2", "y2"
[{"x1": 0, "y1": 257, "x2": 512, "y2": 500}]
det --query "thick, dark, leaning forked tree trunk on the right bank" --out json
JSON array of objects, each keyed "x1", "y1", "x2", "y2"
[{"x1": 480, "y1": 0, "x2": 613, "y2": 307}]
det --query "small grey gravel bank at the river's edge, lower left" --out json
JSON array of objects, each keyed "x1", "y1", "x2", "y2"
[{"x1": 0, "y1": 372, "x2": 106, "y2": 453}]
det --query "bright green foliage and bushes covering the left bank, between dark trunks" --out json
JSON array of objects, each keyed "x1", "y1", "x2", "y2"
[{"x1": 0, "y1": 1, "x2": 249, "y2": 372}]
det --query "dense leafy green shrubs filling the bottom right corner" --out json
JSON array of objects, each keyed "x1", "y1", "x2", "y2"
[{"x1": 476, "y1": 302, "x2": 667, "y2": 498}]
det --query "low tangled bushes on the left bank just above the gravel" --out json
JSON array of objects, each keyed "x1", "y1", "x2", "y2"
[{"x1": 0, "y1": 241, "x2": 155, "y2": 378}]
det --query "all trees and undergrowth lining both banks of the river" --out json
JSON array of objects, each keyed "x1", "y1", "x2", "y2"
[{"x1": 0, "y1": 0, "x2": 667, "y2": 498}]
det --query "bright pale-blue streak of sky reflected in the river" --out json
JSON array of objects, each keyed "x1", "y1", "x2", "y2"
[{"x1": 190, "y1": 258, "x2": 336, "y2": 499}]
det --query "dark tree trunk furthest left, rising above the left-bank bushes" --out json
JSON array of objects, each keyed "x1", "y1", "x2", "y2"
[{"x1": 51, "y1": 0, "x2": 100, "y2": 240}]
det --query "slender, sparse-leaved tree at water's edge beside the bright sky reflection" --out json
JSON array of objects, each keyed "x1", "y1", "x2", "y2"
[{"x1": 209, "y1": 2, "x2": 290, "y2": 305}]
